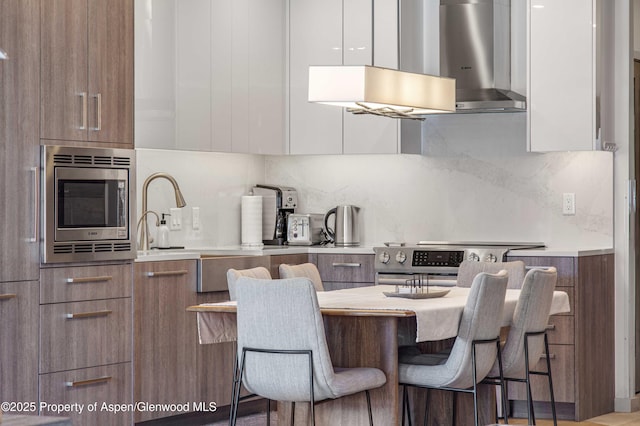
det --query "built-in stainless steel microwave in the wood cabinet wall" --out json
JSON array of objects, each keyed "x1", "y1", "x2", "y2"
[{"x1": 41, "y1": 146, "x2": 135, "y2": 263}]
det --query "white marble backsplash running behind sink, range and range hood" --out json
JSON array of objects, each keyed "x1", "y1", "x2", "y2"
[{"x1": 137, "y1": 114, "x2": 613, "y2": 248}]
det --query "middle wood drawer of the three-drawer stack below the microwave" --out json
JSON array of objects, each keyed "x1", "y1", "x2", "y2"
[{"x1": 40, "y1": 298, "x2": 132, "y2": 373}]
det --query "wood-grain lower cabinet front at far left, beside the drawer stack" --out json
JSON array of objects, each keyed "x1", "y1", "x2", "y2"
[{"x1": 0, "y1": 281, "x2": 38, "y2": 406}]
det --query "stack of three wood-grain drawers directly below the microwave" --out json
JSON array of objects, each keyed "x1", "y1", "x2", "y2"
[{"x1": 36, "y1": 263, "x2": 134, "y2": 426}]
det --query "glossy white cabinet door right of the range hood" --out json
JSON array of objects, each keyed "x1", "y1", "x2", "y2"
[{"x1": 528, "y1": 0, "x2": 596, "y2": 151}]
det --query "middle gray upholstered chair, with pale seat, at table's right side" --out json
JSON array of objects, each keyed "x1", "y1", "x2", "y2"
[{"x1": 398, "y1": 270, "x2": 508, "y2": 426}]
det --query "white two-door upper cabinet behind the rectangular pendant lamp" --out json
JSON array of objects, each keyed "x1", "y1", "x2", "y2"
[{"x1": 288, "y1": 0, "x2": 420, "y2": 154}]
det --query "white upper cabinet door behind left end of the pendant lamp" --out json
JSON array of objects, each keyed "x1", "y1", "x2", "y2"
[{"x1": 289, "y1": 0, "x2": 342, "y2": 154}]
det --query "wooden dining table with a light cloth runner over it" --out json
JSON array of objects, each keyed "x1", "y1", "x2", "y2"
[{"x1": 187, "y1": 285, "x2": 570, "y2": 426}]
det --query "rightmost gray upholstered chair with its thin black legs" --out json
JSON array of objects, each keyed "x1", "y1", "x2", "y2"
[{"x1": 489, "y1": 267, "x2": 558, "y2": 425}]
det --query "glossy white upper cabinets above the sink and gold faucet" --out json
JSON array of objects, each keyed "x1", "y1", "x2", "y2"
[{"x1": 135, "y1": 0, "x2": 286, "y2": 154}]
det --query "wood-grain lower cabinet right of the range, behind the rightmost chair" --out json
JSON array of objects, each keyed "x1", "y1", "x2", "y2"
[{"x1": 509, "y1": 254, "x2": 615, "y2": 421}]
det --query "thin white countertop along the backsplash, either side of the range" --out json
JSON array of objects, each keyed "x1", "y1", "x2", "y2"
[{"x1": 136, "y1": 244, "x2": 614, "y2": 262}]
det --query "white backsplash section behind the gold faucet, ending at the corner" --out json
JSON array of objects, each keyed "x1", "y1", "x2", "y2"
[{"x1": 136, "y1": 149, "x2": 264, "y2": 247}]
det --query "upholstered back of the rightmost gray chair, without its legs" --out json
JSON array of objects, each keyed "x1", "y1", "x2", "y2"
[{"x1": 492, "y1": 268, "x2": 558, "y2": 379}]
